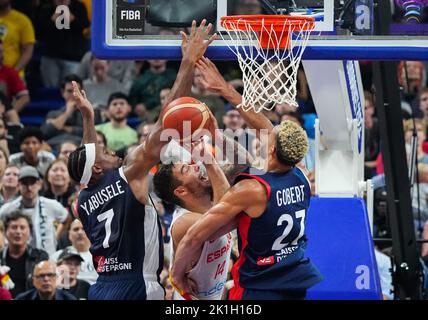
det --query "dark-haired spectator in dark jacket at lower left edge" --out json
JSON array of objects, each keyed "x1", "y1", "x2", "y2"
[{"x1": 0, "y1": 210, "x2": 49, "y2": 297}]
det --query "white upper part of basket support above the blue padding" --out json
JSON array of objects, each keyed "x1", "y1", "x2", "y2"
[{"x1": 303, "y1": 60, "x2": 364, "y2": 197}]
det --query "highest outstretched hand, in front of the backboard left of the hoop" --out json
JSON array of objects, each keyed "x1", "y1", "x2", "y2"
[{"x1": 180, "y1": 19, "x2": 217, "y2": 63}]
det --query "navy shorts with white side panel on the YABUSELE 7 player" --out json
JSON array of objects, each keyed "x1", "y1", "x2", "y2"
[{"x1": 88, "y1": 274, "x2": 165, "y2": 300}]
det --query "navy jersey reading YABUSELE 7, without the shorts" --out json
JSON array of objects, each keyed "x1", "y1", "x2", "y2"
[{"x1": 77, "y1": 168, "x2": 163, "y2": 280}]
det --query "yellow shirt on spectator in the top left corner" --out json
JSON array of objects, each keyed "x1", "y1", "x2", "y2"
[{"x1": 0, "y1": 9, "x2": 36, "y2": 67}]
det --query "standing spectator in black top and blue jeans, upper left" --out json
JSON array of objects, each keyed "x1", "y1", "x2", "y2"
[{"x1": 38, "y1": 0, "x2": 90, "y2": 87}]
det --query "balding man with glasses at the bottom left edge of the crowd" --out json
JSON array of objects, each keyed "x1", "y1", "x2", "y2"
[{"x1": 16, "y1": 260, "x2": 76, "y2": 300}]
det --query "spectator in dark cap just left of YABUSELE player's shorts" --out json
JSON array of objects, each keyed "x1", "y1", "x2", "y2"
[{"x1": 57, "y1": 247, "x2": 90, "y2": 300}]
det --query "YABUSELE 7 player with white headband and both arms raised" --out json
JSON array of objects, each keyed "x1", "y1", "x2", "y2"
[{"x1": 68, "y1": 20, "x2": 215, "y2": 300}]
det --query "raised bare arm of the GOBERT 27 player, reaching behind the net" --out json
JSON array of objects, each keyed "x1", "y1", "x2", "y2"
[{"x1": 197, "y1": 57, "x2": 273, "y2": 135}]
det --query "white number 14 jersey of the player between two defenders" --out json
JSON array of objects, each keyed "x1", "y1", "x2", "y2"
[{"x1": 170, "y1": 208, "x2": 233, "y2": 300}]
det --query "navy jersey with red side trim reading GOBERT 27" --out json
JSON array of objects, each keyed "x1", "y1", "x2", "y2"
[{"x1": 231, "y1": 168, "x2": 321, "y2": 299}]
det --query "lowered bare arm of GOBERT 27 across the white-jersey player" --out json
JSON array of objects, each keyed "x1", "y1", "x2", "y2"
[{"x1": 172, "y1": 180, "x2": 267, "y2": 292}]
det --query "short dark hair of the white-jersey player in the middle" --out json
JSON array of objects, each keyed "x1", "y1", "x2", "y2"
[{"x1": 153, "y1": 163, "x2": 183, "y2": 206}]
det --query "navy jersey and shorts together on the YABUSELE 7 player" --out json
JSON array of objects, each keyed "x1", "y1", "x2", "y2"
[{"x1": 77, "y1": 168, "x2": 164, "y2": 300}]
